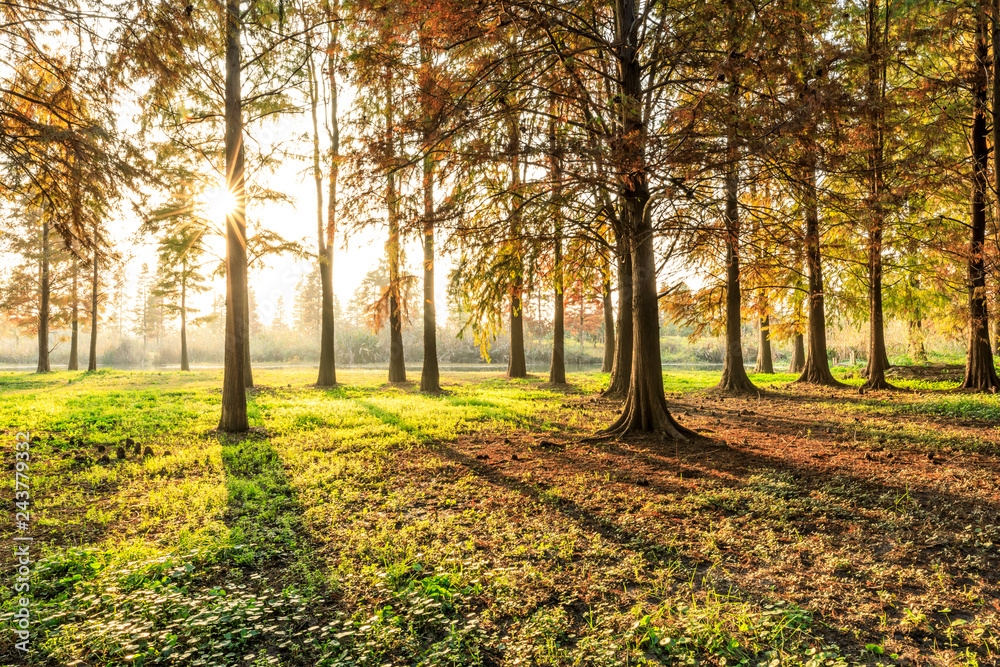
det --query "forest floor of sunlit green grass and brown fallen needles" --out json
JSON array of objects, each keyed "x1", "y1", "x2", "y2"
[{"x1": 0, "y1": 370, "x2": 1000, "y2": 667}]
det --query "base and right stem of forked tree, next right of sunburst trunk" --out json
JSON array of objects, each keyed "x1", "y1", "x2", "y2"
[{"x1": 316, "y1": 9, "x2": 340, "y2": 387}]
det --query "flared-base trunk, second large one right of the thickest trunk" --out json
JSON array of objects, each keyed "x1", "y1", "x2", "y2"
[{"x1": 797, "y1": 157, "x2": 843, "y2": 387}]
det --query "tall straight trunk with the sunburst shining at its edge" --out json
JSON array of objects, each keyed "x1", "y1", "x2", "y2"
[{"x1": 219, "y1": 0, "x2": 250, "y2": 433}]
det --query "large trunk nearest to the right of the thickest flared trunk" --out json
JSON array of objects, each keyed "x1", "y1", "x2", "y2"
[{"x1": 716, "y1": 95, "x2": 758, "y2": 394}]
